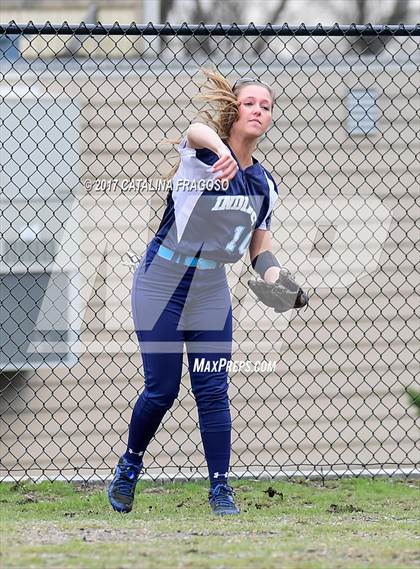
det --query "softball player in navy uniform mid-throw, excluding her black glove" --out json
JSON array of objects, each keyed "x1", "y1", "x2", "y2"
[{"x1": 108, "y1": 70, "x2": 280, "y2": 515}]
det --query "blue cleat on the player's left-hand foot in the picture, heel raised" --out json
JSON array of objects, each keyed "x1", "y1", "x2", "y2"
[{"x1": 108, "y1": 456, "x2": 142, "y2": 514}]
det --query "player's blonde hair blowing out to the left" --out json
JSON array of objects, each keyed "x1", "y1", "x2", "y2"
[{"x1": 164, "y1": 68, "x2": 275, "y2": 178}]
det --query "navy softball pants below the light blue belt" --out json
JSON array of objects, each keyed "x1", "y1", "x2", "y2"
[{"x1": 125, "y1": 241, "x2": 232, "y2": 485}]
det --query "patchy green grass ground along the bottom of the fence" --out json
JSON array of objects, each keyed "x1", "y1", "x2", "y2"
[{"x1": 0, "y1": 479, "x2": 420, "y2": 569}]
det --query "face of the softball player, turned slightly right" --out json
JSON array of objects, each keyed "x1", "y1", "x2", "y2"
[{"x1": 232, "y1": 85, "x2": 273, "y2": 138}]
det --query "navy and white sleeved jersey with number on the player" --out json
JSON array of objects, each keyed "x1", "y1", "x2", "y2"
[{"x1": 154, "y1": 138, "x2": 278, "y2": 263}]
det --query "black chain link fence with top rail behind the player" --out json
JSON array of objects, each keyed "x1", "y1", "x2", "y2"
[{"x1": 0, "y1": 22, "x2": 420, "y2": 480}]
